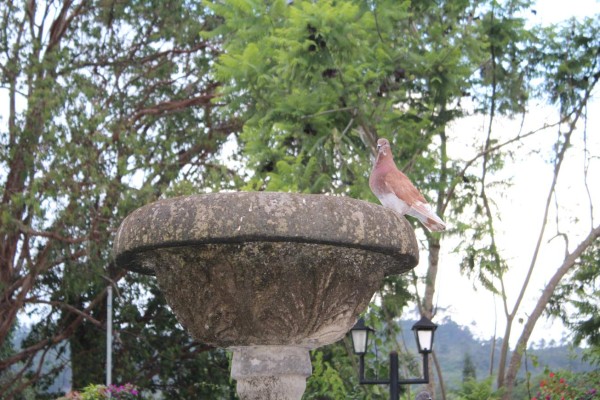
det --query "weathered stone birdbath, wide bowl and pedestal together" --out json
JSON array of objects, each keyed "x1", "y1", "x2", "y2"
[{"x1": 114, "y1": 192, "x2": 418, "y2": 400}]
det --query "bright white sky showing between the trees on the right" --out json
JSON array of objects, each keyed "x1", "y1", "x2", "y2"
[{"x1": 416, "y1": 0, "x2": 600, "y2": 345}]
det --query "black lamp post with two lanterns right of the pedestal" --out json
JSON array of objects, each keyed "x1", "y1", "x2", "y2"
[{"x1": 350, "y1": 317, "x2": 437, "y2": 400}]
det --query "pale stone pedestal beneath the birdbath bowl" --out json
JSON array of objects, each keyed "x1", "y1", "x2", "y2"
[{"x1": 231, "y1": 346, "x2": 312, "y2": 400}]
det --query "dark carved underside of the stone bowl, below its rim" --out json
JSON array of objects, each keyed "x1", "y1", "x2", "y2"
[{"x1": 151, "y1": 242, "x2": 389, "y2": 348}]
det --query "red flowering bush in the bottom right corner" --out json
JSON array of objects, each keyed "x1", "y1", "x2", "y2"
[{"x1": 531, "y1": 372, "x2": 600, "y2": 400}]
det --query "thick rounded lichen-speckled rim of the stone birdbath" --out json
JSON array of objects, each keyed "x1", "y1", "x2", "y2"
[{"x1": 113, "y1": 192, "x2": 418, "y2": 275}]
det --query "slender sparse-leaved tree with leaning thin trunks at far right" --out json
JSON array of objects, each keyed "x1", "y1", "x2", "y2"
[{"x1": 464, "y1": 20, "x2": 600, "y2": 399}]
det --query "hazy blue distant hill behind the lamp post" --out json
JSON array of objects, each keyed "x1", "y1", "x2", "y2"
[{"x1": 401, "y1": 318, "x2": 593, "y2": 389}]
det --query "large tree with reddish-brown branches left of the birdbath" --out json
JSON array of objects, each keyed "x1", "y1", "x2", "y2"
[{"x1": 0, "y1": 0, "x2": 237, "y2": 399}]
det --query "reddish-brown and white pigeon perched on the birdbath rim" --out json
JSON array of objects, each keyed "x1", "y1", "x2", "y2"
[{"x1": 369, "y1": 139, "x2": 446, "y2": 232}]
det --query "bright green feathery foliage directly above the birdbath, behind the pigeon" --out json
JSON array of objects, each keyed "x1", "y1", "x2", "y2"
[{"x1": 206, "y1": 1, "x2": 492, "y2": 199}]
